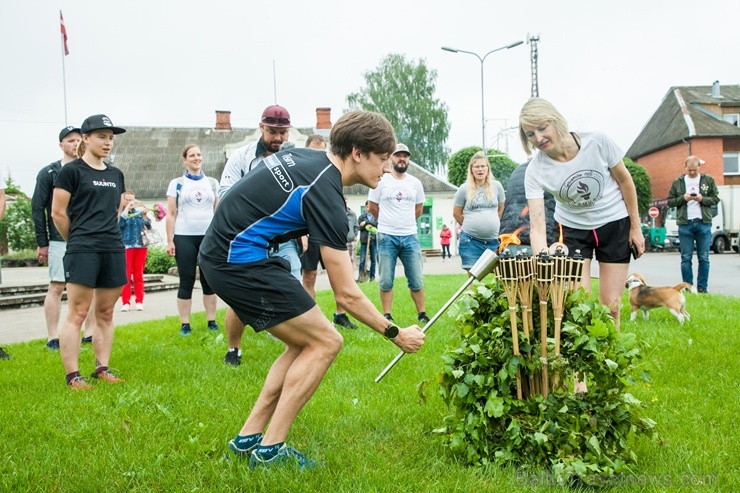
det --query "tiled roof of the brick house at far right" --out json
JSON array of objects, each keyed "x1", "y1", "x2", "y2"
[{"x1": 627, "y1": 85, "x2": 740, "y2": 159}]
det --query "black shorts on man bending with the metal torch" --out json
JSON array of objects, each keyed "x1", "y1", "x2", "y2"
[{"x1": 198, "y1": 256, "x2": 316, "y2": 332}]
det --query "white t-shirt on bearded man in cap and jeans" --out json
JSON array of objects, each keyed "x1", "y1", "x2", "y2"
[{"x1": 367, "y1": 173, "x2": 425, "y2": 236}]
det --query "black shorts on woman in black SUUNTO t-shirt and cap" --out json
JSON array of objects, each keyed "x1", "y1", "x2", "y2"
[{"x1": 64, "y1": 250, "x2": 126, "y2": 288}]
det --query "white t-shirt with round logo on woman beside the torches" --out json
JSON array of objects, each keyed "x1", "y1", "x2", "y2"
[{"x1": 524, "y1": 132, "x2": 629, "y2": 230}]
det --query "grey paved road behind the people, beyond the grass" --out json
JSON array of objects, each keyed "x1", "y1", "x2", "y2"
[{"x1": 0, "y1": 252, "x2": 740, "y2": 345}]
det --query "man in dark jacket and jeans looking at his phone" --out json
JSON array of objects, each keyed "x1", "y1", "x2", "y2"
[{"x1": 668, "y1": 156, "x2": 719, "y2": 293}]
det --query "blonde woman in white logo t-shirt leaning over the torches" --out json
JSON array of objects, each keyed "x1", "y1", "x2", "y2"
[{"x1": 519, "y1": 98, "x2": 645, "y2": 330}]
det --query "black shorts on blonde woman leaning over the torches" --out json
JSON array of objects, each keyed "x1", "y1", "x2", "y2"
[{"x1": 563, "y1": 217, "x2": 630, "y2": 264}]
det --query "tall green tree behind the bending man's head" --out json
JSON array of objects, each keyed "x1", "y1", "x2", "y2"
[{"x1": 347, "y1": 54, "x2": 450, "y2": 172}]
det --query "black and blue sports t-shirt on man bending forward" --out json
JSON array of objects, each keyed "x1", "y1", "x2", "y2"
[{"x1": 200, "y1": 149, "x2": 349, "y2": 264}]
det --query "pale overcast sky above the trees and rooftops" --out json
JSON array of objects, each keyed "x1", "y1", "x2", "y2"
[{"x1": 0, "y1": 0, "x2": 740, "y2": 195}]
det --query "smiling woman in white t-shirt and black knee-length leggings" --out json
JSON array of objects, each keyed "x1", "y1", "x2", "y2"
[{"x1": 167, "y1": 144, "x2": 218, "y2": 336}]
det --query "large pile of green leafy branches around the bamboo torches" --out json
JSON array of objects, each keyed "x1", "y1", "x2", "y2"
[{"x1": 435, "y1": 279, "x2": 658, "y2": 484}]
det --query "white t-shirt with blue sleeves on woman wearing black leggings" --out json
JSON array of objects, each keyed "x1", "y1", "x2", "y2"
[{"x1": 167, "y1": 176, "x2": 216, "y2": 236}]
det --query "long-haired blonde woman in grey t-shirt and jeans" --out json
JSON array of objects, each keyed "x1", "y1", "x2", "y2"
[{"x1": 452, "y1": 151, "x2": 506, "y2": 270}]
